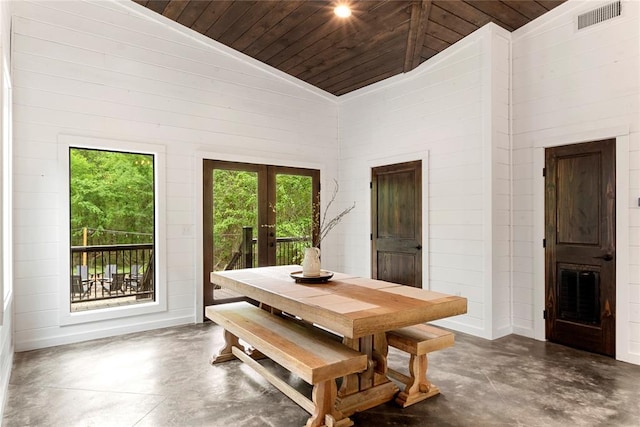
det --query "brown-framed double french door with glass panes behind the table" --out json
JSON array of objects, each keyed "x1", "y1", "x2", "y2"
[{"x1": 203, "y1": 160, "x2": 320, "y2": 307}]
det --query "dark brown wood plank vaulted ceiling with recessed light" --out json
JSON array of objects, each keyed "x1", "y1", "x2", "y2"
[{"x1": 134, "y1": 0, "x2": 566, "y2": 95}]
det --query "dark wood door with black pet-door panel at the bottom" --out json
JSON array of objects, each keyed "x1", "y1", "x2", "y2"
[{"x1": 545, "y1": 140, "x2": 616, "y2": 356}]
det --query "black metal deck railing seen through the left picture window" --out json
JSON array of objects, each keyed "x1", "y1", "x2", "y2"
[{"x1": 69, "y1": 243, "x2": 155, "y2": 304}]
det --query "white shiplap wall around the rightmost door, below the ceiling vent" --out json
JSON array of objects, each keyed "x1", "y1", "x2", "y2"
[{"x1": 512, "y1": 0, "x2": 640, "y2": 363}]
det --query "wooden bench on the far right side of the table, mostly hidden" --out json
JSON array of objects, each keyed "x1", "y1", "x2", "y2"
[{"x1": 387, "y1": 324, "x2": 454, "y2": 408}]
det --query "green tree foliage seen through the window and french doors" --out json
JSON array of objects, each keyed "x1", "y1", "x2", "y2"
[{"x1": 70, "y1": 148, "x2": 313, "y2": 269}]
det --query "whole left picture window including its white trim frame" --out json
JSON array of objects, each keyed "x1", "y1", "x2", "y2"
[{"x1": 58, "y1": 134, "x2": 167, "y2": 325}]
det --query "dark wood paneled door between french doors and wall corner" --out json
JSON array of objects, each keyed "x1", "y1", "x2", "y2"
[{"x1": 371, "y1": 161, "x2": 422, "y2": 288}]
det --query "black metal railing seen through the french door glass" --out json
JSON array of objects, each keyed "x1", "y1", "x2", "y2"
[{"x1": 225, "y1": 227, "x2": 311, "y2": 270}]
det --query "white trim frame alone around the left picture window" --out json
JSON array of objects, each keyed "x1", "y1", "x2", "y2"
[{"x1": 58, "y1": 135, "x2": 167, "y2": 325}]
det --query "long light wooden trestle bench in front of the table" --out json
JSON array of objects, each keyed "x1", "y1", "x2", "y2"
[{"x1": 205, "y1": 302, "x2": 367, "y2": 427}]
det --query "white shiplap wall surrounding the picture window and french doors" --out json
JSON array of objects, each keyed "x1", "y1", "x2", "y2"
[{"x1": 13, "y1": 1, "x2": 338, "y2": 350}]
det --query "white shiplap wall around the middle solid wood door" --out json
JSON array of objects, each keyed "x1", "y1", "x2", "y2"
[{"x1": 339, "y1": 25, "x2": 510, "y2": 338}]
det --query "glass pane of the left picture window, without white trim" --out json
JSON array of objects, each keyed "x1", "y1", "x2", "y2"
[{"x1": 69, "y1": 148, "x2": 155, "y2": 312}]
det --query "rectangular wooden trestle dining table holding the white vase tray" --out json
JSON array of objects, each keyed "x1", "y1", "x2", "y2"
[{"x1": 210, "y1": 265, "x2": 467, "y2": 416}]
